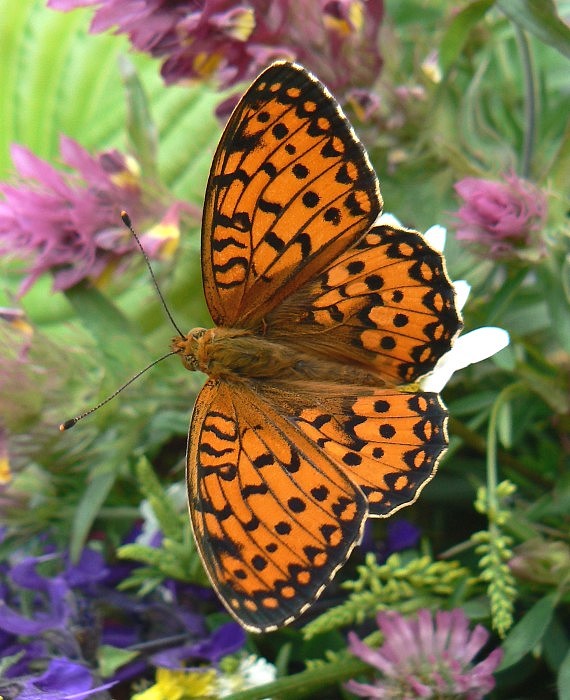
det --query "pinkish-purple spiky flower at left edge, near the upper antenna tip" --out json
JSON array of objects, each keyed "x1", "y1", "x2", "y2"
[{"x1": 0, "y1": 137, "x2": 183, "y2": 294}]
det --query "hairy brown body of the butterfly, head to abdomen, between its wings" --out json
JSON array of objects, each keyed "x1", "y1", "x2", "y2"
[{"x1": 171, "y1": 328, "x2": 384, "y2": 386}]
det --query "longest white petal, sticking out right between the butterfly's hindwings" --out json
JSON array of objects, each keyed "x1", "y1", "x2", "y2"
[{"x1": 420, "y1": 326, "x2": 509, "y2": 392}]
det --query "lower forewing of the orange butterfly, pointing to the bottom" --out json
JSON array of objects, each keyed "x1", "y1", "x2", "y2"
[{"x1": 188, "y1": 380, "x2": 367, "y2": 632}]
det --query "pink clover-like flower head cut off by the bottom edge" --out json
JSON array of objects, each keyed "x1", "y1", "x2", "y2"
[{"x1": 346, "y1": 608, "x2": 503, "y2": 700}]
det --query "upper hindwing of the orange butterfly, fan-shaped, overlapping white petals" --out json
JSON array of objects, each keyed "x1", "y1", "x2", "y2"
[{"x1": 265, "y1": 226, "x2": 462, "y2": 386}]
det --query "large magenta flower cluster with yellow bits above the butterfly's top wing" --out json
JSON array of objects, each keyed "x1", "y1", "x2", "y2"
[{"x1": 48, "y1": 0, "x2": 384, "y2": 113}]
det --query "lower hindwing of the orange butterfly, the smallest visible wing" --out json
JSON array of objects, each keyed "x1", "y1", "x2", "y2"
[{"x1": 259, "y1": 382, "x2": 448, "y2": 517}]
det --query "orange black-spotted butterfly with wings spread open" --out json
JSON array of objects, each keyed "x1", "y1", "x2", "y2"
[{"x1": 172, "y1": 62, "x2": 461, "y2": 632}]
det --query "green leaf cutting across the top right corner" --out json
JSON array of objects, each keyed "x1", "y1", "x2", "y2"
[{"x1": 497, "y1": 0, "x2": 570, "y2": 58}]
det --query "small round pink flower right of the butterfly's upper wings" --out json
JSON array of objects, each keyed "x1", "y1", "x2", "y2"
[{"x1": 448, "y1": 174, "x2": 547, "y2": 259}]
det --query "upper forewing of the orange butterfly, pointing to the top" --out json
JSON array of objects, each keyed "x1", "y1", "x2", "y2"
[{"x1": 202, "y1": 62, "x2": 382, "y2": 328}]
